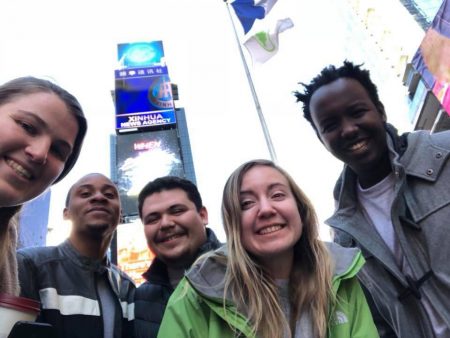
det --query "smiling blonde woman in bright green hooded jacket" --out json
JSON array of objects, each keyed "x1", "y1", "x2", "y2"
[{"x1": 159, "y1": 160, "x2": 378, "y2": 338}]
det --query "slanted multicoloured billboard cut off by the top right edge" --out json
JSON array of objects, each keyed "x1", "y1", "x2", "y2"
[{"x1": 412, "y1": 0, "x2": 450, "y2": 115}]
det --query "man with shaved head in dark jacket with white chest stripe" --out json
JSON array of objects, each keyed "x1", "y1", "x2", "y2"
[{"x1": 17, "y1": 173, "x2": 135, "y2": 338}]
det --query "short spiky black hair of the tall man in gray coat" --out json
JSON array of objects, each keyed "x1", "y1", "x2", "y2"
[{"x1": 293, "y1": 60, "x2": 384, "y2": 133}]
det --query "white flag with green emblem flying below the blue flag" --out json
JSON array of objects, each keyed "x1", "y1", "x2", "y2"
[{"x1": 244, "y1": 18, "x2": 294, "y2": 63}]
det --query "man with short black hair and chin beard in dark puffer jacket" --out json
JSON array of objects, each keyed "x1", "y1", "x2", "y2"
[{"x1": 135, "y1": 176, "x2": 220, "y2": 338}]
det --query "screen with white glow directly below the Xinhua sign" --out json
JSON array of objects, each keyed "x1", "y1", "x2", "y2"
[{"x1": 116, "y1": 129, "x2": 184, "y2": 216}]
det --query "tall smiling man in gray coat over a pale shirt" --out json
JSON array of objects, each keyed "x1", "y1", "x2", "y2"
[{"x1": 295, "y1": 61, "x2": 450, "y2": 338}]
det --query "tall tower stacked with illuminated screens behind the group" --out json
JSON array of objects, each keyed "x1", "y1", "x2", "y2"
[{"x1": 111, "y1": 41, "x2": 196, "y2": 284}]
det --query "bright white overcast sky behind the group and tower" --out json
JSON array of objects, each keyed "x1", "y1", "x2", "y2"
[{"x1": 0, "y1": 0, "x2": 422, "y2": 244}]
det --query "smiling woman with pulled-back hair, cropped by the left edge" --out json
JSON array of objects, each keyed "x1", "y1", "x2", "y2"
[{"x1": 0, "y1": 77, "x2": 87, "y2": 295}]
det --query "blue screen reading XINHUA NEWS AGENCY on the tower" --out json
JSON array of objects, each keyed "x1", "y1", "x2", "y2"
[{"x1": 115, "y1": 66, "x2": 176, "y2": 129}]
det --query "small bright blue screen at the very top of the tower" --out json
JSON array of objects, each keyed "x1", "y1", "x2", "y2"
[{"x1": 117, "y1": 41, "x2": 164, "y2": 68}]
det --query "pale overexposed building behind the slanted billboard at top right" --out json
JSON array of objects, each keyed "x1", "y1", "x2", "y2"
[{"x1": 347, "y1": 0, "x2": 450, "y2": 131}]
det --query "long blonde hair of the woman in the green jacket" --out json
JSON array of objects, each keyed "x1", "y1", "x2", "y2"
[{"x1": 222, "y1": 160, "x2": 332, "y2": 338}]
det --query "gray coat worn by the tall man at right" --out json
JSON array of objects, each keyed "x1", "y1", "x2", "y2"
[{"x1": 326, "y1": 126, "x2": 450, "y2": 338}]
